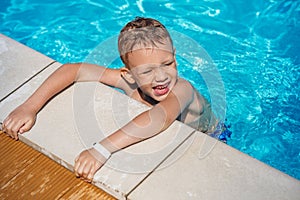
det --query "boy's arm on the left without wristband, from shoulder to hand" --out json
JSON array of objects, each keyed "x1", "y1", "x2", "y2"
[{"x1": 2, "y1": 64, "x2": 122, "y2": 140}]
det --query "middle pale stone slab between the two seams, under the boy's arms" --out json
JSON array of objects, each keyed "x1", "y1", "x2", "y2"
[{"x1": 0, "y1": 63, "x2": 194, "y2": 199}]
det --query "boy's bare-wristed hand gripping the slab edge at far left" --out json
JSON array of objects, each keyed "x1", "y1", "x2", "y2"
[{"x1": 2, "y1": 105, "x2": 36, "y2": 140}]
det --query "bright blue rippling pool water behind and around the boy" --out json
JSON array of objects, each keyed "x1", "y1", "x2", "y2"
[{"x1": 0, "y1": 0, "x2": 300, "y2": 179}]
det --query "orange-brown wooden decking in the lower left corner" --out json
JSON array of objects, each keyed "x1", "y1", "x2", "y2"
[{"x1": 0, "y1": 132, "x2": 114, "y2": 199}]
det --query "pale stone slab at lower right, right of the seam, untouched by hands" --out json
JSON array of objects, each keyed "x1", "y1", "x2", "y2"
[{"x1": 128, "y1": 132, "x2": 300, "y2": 200}]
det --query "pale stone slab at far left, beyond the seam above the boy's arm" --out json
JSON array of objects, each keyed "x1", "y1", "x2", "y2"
[{"x1": 0, "y1": 34, "x2": 54, "y2": 101}]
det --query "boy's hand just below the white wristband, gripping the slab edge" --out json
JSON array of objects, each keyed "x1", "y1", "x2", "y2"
[{"x1": 74, "y1": 148, "x2": 106, "y2": 182}]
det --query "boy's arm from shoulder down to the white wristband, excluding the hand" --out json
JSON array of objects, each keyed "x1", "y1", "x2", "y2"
[{"x1": 100, "y1": 80, "x2": 194, "y2": 152}]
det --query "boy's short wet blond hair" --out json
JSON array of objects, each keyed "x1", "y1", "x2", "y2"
[{"x1": 118, "y1": 17, "x2": 174, "y2": 64}]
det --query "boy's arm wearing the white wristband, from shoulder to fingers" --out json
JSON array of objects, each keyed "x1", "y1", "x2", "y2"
[{"x1": 74, "y1": 80, "x2": 194, "y2": 181}]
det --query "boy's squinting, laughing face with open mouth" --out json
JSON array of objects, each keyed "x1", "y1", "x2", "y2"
[{"x1": 127, "y1": 45, "x2": 177, "y2": 101}]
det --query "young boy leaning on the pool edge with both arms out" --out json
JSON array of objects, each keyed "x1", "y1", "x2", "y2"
[{"x1": 2, "y1": 18, "x2": 230, "y2": 182}]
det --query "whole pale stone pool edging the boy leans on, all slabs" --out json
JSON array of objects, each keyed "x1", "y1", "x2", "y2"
[{"x1": 0, "y1": 35, "x2": 300, "y2": 200}]
